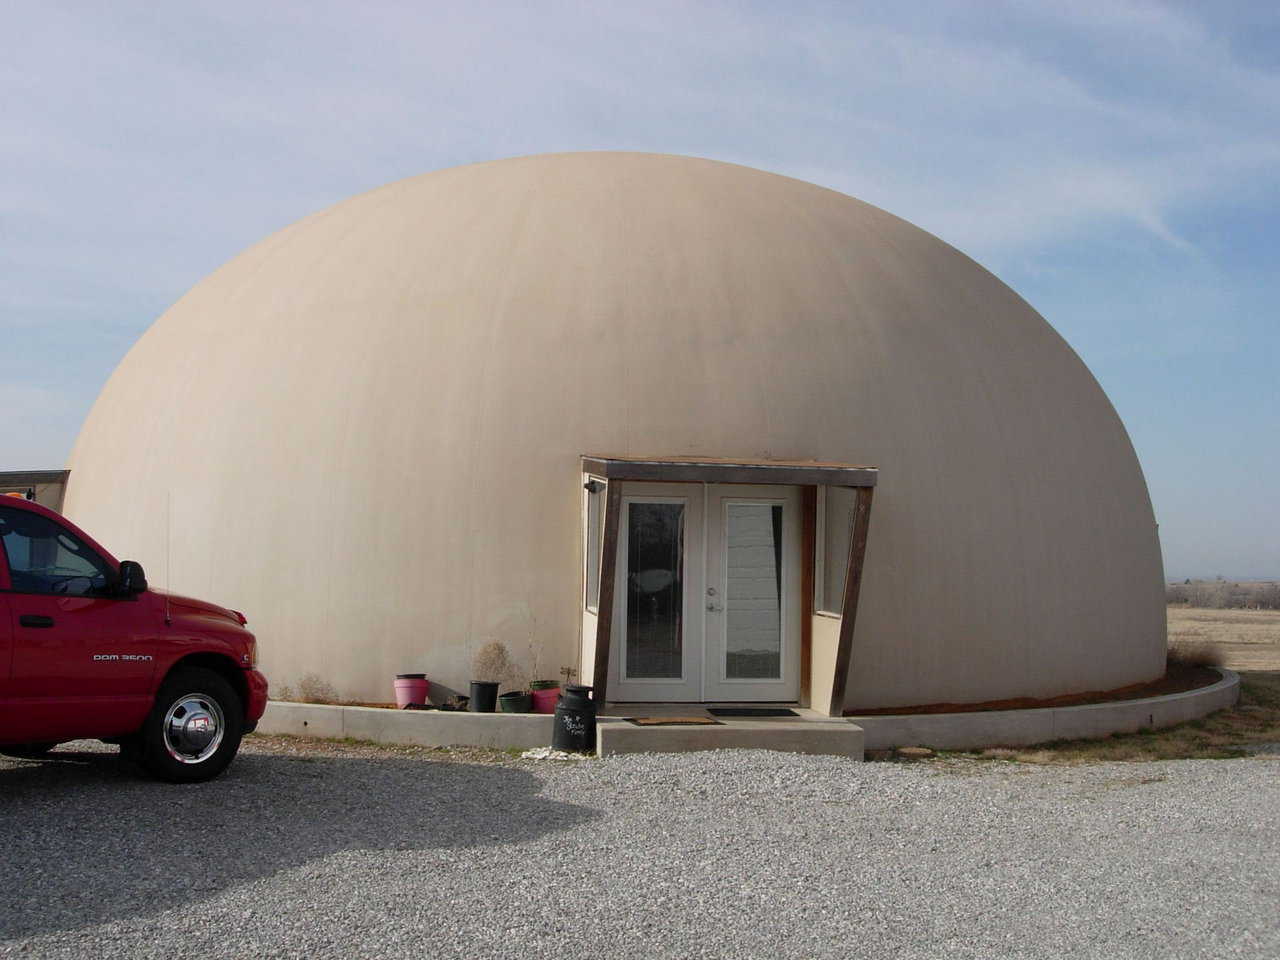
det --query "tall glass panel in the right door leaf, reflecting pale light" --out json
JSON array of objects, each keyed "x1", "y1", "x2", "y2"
[{"x1": 724, "y1": 503, "x2": 782, "y2": 680}]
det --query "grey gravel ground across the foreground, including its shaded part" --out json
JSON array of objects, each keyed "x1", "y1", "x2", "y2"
[{"x1": 0, "y1": 739, "x2": 1280, "y2": 960}]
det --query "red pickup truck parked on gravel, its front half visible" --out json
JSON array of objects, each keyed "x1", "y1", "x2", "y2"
[{"x1": 0, "y1": 495, "x2": 266, "y2": 782}]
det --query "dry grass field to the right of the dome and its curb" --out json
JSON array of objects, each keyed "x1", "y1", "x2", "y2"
[{"x1": 942, "y1": 605, "x2": 1280, "y2": 763}]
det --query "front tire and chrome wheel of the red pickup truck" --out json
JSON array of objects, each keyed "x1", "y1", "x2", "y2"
[{"x1": 137, "y1": 667, "x2": 244, "y2": 783}]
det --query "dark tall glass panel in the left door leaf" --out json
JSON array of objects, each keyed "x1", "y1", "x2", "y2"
[{"x1": 626, "y1": 503, "x2": 685, "y2": 680}]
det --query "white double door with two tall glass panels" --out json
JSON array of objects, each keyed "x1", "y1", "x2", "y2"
[{"x1": 609, "y1": 483, "x2": 800, "y2": 703}]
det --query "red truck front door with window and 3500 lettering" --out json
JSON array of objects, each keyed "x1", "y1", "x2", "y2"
[{"x1": 0, "y1": 506, "x2": 161, "y2": 740}]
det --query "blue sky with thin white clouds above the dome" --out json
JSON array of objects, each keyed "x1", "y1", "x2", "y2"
[{"x1": 0, "y1": 0, "x2": 1280, "y2": 577}]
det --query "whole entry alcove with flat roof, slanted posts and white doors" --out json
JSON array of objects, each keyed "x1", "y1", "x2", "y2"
[{"x1": 581, "y1": 456, "x2": 878, "y2": 717}]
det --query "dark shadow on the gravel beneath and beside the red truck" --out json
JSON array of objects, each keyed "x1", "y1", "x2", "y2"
[{"x1": 0, "y1": 753, "x2": 596, "y2": 941}]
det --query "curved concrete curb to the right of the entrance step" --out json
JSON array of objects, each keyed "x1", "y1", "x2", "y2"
[{"x1": 849, "y1": 669, "x2": 1240, "y2": 750}]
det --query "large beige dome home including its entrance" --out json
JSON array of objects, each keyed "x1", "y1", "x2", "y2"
[{"x1": 65, "y1": 154, "x2": 1165, "y2": 713}]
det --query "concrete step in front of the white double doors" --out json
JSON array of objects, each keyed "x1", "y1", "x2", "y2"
[{"x1": 595, "y1": 718, "x2": 863, "y2": 760}]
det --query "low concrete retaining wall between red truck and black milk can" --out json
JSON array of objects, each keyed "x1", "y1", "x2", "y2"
[{"x1": 257, "y1": 700, "x2": 553, "y2": 750}]
